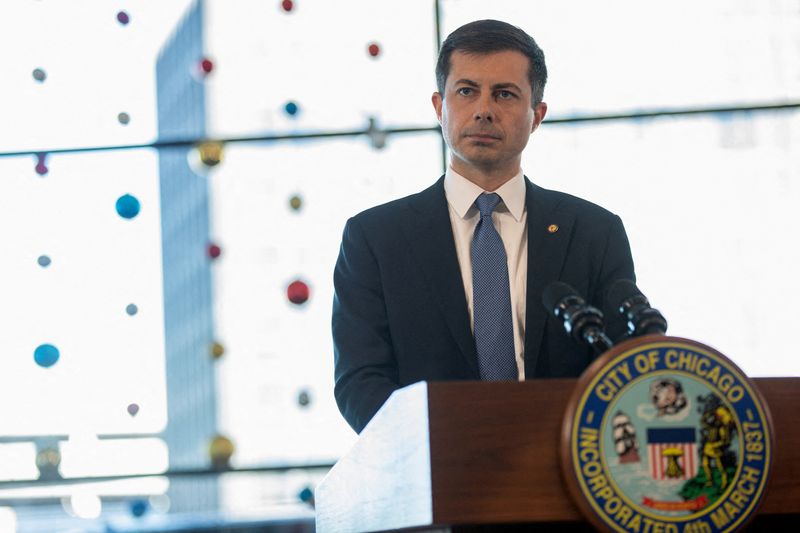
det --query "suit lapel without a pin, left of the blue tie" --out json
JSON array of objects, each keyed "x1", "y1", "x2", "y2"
[{"x1": 403, "y1": 176, "x2": 479, "y2": 379}]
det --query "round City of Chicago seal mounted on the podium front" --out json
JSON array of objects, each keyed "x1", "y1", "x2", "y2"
[{"x1": 561, "y1": 335, "x2": 773, "y2": 533}]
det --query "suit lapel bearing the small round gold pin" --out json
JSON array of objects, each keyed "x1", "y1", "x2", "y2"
[{"x1": 525, "y1": 178, "x2": 574, "y2": 379}]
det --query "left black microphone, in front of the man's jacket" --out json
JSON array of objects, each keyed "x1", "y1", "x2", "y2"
[{"x1": 542, "y1": 281, "x2": 613, "y2": 355}]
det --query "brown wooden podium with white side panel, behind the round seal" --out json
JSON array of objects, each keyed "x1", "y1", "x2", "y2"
[{"x1": 316, "y1": 378, "x2": 800, "y2": 533}]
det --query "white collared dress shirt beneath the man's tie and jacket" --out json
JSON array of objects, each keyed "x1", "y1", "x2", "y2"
[{"x1": 444, "y1": 167, "x2": 528, "y2": 381}]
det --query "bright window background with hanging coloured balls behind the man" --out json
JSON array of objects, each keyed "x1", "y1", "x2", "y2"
[{"x1": 0, "y1": 0, "x2": 800, "y2": 533}]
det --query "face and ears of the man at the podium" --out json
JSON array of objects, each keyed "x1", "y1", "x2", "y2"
[{"x1": 432, "y1": 50, "x2": 547, "y2": 183}]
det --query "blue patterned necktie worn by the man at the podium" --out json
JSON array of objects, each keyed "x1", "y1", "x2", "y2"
[{"x1": 472, "y1": 193, "x2": 518, "y2": 381}]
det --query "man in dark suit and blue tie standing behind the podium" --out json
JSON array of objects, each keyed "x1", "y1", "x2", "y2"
[{"x1": 333, "y1": 20, "x2": 634, "y2": 432}]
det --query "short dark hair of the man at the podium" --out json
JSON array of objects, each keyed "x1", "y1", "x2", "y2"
[{"x1": 436, "y1": 20, "x2": 547, "y2": 105}]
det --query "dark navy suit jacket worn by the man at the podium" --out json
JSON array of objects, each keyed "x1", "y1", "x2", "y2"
[{"x1": 333, "y1": 177, "x2": 634, "y2": 432}]
